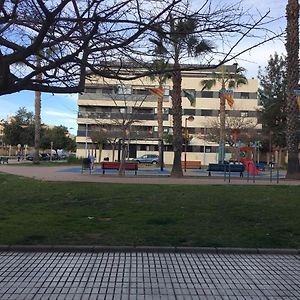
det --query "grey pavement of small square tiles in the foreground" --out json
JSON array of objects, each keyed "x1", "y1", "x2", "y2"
[{"x1": 0, "y1": 251, "x2": 300, "y2": 300}]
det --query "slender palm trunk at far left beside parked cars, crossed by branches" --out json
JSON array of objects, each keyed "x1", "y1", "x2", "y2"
[{"x1": 33, "y1": 56, "x2": 42, "y2": 164}]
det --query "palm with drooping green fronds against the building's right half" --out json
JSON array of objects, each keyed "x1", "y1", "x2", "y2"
[{"x1": 201, "y1": 64, "x2": 248, "y2": 163}]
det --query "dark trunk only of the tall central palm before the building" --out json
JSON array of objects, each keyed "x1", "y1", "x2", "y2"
[{"x1": 171, "y1": 63, "x2": 183, "y2": 177}]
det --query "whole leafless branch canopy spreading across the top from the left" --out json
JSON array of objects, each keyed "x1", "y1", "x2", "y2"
[{"x1": 0, "y1": 0, "x2": 277, "y2": 95}]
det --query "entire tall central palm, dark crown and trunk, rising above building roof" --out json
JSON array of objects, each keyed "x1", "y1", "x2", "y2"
[{"x1": 154, "y1": 14, "x2": 213, "y2": 177}]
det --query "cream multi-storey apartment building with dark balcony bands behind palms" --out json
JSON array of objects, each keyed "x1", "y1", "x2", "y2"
[{"x1": 76, "y1": 65, "x2": 261, "y2": 164}]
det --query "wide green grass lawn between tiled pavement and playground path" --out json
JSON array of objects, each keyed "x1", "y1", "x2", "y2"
[{"x1": 0, "y1": 173, "x2": 300, "y2": 248}]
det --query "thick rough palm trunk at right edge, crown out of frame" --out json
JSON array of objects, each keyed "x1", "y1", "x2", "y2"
[{"x1": 286, "y1": 0, "x2": 300, "y2": 179}]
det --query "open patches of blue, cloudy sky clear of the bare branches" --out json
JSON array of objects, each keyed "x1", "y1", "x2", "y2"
[{"x1": 0, "y1": 0, "x2": 287, "y2": 135}]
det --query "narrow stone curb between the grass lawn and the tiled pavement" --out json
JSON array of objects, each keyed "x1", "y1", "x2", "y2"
[{"x1": 0, "y1": 245, "x2": 300, "y2": 255}]
